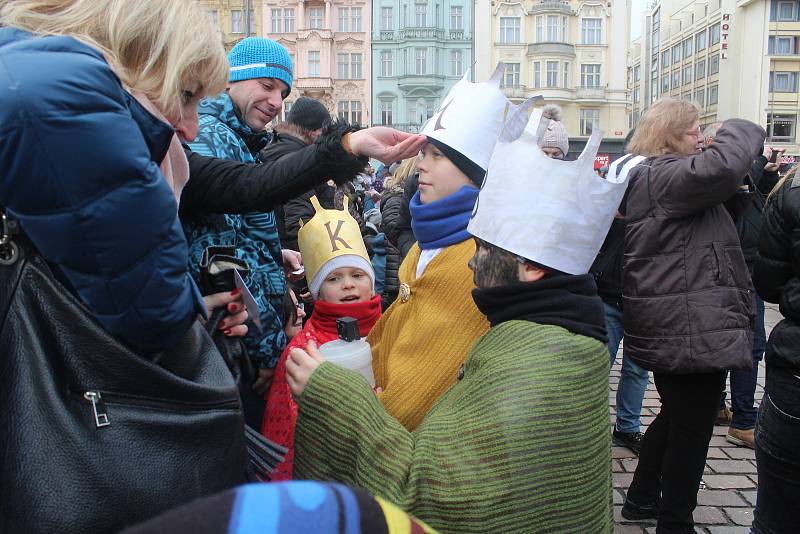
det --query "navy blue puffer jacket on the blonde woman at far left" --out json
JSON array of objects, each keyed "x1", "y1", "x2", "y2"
[{"x1": 0, "y1": 28, "x2": 204, "y2": 352}]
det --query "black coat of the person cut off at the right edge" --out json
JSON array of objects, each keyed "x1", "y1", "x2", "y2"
[{"x1": 753, "y1": 175, "x2": 800, "y2": 375}]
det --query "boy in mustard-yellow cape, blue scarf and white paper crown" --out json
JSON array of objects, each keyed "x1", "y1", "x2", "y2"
[{"x1": 369, "y1": 64, "x2": 540, "y2": 430}]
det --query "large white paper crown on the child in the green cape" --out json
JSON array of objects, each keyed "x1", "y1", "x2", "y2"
[{"x1": 467, "y1": 106, "x2": 643, "y2": 274}]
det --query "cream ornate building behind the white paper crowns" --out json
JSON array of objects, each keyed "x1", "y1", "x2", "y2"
[{"x1": 475, "y1": 0, "x2": 630, "y2": 155}]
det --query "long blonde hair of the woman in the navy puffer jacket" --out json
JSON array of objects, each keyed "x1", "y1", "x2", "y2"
[{"x1": 0, "y1": 0, "x2": 228, "y2": 115}]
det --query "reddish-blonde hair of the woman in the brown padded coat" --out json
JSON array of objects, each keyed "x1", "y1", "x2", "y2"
[{"x1": 628, "y1": 98, "x2": 700, "y2": 156}]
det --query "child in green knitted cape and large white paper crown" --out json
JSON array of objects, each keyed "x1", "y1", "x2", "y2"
[{"x1": 287, "y1": 102, "x2": 624, "y2": 534}]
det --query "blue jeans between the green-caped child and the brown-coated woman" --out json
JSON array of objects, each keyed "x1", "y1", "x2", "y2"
[{"x1": 603, "y1": 302, "x2": 647, "y2": 432}]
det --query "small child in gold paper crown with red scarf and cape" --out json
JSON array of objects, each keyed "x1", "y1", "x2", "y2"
[{"x1": 261, "y1": 196, "x2": 381, "y2": 481}]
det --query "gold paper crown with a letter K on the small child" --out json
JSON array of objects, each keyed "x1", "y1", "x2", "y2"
[{"x1": 297, "y1": 196, "x2": 370, "y2": 285}]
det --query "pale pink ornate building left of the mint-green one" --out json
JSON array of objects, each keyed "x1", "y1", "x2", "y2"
[{"x1": 262, "y1": 0, "x2": 372, "y2": 124}]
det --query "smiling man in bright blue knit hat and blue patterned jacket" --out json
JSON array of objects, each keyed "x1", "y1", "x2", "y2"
[{"x1": 182, "y1": 37, "x2": 301, "y2": 428}]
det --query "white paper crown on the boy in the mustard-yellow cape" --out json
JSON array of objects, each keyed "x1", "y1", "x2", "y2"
[{"x1": 420, "y1": 63, "x2": 516, "y2": 170}]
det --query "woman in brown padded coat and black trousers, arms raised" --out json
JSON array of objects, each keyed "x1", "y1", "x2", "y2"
[{"x1": 622, "y1": 98, "x2": 766, "y2": 534}]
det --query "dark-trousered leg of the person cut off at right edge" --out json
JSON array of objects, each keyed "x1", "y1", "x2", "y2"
[{"x1": 752, "y1": 374, "x2": 800, "y2": 534}]
